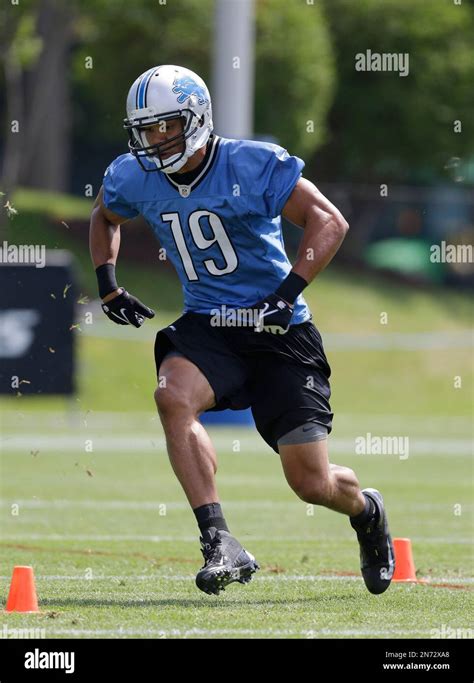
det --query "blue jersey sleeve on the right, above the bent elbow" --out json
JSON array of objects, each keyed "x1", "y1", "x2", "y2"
[{"x1": 249, "y1": 145, "x2": 304, "y2": 218}]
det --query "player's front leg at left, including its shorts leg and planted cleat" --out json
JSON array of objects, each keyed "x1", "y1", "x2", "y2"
[{"x1": 155, "y1": 313, "x2": 258, "y2": 594}]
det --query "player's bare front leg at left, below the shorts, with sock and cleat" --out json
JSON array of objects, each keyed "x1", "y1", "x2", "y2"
[{"x1": 155, "y1": 352, "x2": 258, "y2": 594}]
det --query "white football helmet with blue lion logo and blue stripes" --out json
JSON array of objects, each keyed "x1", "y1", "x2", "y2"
[{"x1": 124, "y1": 64, "x2": 213, "y2": 173}]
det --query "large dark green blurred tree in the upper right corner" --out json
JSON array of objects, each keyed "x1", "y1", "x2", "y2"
[{"x1": 318, "y1": 0, "x2": 474, "y2": 181}]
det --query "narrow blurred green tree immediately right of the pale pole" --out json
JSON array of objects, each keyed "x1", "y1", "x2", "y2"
[{"x1": 255, "y1": 0, "x2": 335, "y2": 156}]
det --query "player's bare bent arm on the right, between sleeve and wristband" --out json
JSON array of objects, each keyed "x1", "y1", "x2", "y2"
[{"x1": 282, "y1": 178, "x2": 349, "y2": 283}]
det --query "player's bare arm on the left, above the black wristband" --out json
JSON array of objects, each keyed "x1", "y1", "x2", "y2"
[{"x1": 89, "y1": 187, "x2": 129, "y2": 302}]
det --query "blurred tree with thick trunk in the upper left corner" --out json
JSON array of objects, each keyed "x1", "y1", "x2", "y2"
[{"x1": 0, "y1": 0, "x2": 73, "y2": 190}]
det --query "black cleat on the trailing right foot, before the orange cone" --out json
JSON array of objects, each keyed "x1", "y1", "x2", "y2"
[{"x1": 353, "y1": 489, "x2": 395, "y2": 595}]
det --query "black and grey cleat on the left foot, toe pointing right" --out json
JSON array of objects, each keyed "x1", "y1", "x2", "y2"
[{"x1": 196, "y1": 527, "x2": 259, "y2": 595}]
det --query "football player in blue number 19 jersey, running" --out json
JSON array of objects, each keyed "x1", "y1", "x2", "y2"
[{"x1": 90, "y1": 65, "x2": 394, "y2": 594}]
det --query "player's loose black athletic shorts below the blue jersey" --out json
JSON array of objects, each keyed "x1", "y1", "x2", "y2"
[{"x1": 155, "y1": 313, "x2": 333, "y2": 453}]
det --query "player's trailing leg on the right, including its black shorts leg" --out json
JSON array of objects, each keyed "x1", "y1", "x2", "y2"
[{"x1": 248, "y1": 323, "x2": 395, "y2": 593}]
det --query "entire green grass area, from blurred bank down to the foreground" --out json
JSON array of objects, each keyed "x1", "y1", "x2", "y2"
[{"x1": 0, "y1": 194, "x2": 474, "y2": 638}]
